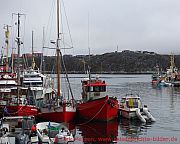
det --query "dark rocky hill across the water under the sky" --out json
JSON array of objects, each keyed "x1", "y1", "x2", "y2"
[{"x1": 6, "y1": 50, "x2": 180, "y2": 73}]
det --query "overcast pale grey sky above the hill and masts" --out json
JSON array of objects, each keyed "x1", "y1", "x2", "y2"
[{"x1": 0, "y1": 0, "x2": 180, "y2": 55}]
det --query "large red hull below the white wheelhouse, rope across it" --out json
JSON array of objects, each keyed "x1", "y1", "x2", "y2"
[{"x1": 77, "y1": 96, "x2": 118, "y2": 121}]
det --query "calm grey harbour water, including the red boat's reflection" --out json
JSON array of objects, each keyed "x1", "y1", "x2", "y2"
[{"x1": 59, "y1": 74, "x2": 180, "y2": 144}]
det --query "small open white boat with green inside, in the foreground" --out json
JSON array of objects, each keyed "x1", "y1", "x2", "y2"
[{"x1": 33, "y1": 122, "x2": 74, "y2": 144}]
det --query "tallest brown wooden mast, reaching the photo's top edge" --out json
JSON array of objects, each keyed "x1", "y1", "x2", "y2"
[{"x1": 56, "y1": 0, "x2": 61, "y2": 96}]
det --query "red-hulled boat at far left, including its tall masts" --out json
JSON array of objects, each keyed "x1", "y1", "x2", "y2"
[{"x1": 0, "y1": 13, "x2": 38, "y2": 116}]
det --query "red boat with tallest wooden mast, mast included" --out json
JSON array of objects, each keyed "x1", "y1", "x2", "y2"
[{"x1": 37, "y1": 0, "x2": 76, "y2": 122}]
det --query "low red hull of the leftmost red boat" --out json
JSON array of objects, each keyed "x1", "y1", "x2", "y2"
[{"x1": 4, "y1": 105, "x2": 38, "y2": 116}]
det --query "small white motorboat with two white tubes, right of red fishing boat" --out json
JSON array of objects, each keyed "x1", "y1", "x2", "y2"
[{"x1": 119, "y1": 94, "x2": 156, "y2": 123}]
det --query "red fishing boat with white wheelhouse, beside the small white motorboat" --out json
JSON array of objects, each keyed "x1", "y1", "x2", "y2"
[{"x1": 77, "y1": 77, "x2": 118, "y2": 121}]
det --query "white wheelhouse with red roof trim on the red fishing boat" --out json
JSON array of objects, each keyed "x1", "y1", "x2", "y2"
[{"x1": 81, "y1": 78, "x2": 107, "y2": 101}]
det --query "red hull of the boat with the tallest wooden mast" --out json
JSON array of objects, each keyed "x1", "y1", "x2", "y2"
[{"x1": 37, "y1": 106, "x2": 76, "y2": 122}]
